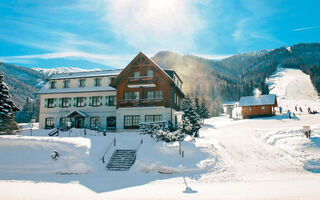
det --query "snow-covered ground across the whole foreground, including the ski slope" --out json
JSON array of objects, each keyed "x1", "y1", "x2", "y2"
[{"x1": 0, "y1": 69, "x2": 320, "y2": 200}]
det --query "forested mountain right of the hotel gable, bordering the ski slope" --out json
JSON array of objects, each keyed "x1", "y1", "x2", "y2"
[{"x1": 152, "y1": 43, "x2": 320, "y2": 114}]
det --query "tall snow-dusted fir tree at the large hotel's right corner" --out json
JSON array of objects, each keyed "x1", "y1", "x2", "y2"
[{"x1": 181, "y1": 96, "x2": 201, "y2": 137}]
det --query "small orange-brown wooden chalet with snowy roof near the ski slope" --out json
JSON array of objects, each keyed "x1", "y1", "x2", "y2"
[{"x1": 239, "y1": 94, "x2": 278, "y2": 119}]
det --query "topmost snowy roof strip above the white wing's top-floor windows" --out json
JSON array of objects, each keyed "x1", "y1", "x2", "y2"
[{"x1": 50, "y1": 69, "x2": 122, "y2": 80}]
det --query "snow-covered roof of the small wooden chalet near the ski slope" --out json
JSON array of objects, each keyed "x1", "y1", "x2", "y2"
[{"x1": 240, "y1": 94, "x2": 276, "y2": 106}]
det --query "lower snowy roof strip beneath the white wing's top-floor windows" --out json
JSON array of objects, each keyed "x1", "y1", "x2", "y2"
[{"x1": 38, "y1": 84, "x2": 116, "y2": 94}]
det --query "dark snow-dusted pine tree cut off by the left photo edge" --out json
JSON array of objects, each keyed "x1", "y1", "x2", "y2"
[{"x1": 0, "y1": 74, "x2": 19, "y2": 134}]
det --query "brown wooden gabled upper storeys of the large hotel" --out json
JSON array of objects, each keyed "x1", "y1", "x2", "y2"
[{"x1": 110, "y1": 52, "x2": 184, "y2": 110}]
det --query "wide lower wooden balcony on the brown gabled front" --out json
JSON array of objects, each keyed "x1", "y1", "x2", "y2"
[{"x1": 119, "y1": 98, "x2": 166, "y2": 107}]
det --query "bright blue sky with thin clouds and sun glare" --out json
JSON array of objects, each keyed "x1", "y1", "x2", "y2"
[{"x1": 0, "y1": 0, "x2": 320, "y2": 69}]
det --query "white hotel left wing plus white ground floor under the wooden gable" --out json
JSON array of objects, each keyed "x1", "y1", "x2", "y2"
[{"x1": 39, "y1": 71, "x2": 182, "y2": 130}]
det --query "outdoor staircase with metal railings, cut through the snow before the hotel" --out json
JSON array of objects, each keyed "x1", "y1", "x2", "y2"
[{"x1": 107, "y1": 149, "x2": 136, "y2": 171}]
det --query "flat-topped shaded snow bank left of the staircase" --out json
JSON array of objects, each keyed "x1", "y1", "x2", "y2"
[{"x1": 0, "y1": 136, "x2": 91, "y2": 174}]
